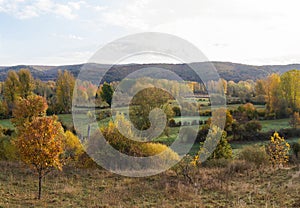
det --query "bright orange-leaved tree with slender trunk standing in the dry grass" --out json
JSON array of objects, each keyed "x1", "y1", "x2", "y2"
[{"x1": 16, "y1": 116, "x2": 64, "y2": 199}]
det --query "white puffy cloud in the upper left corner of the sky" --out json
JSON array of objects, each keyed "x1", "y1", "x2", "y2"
[{"x1": 0, "y1": 0, "x2": 84, "y2": 20}]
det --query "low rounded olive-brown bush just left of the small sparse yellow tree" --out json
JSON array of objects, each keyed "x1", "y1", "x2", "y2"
[{"x1": 238, "y1": 145, "x2": 269, "y2": 168}]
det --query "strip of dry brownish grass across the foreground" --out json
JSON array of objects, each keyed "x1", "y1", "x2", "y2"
[{"x1": 0, "y1": 162, "x2": 300, "y2": 207}]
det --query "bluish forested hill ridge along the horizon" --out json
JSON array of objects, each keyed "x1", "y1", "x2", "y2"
[{"x1": 0, "y1": 62, "x2": 300, "y2": 82}]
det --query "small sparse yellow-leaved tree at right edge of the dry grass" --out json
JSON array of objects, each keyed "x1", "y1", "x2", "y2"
[{"x1": 266, "y1": 132, "x2": 290, "y2": 167}]
